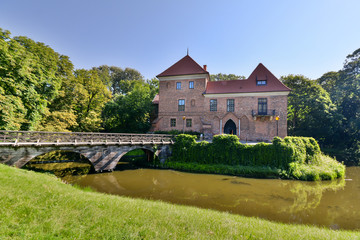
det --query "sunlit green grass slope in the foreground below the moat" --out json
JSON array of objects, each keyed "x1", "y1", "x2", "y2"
[{"x1": 0, "y1": 164, "x2": 360, "y2": 239}]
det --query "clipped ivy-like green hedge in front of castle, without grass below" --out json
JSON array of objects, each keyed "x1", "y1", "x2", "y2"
[{"x1": 169, "y1": 134, "x2": 321, "y2": 170}]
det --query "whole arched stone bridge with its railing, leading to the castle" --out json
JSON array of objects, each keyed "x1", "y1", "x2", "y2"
[{"x1": 0, "y1": 130, "x2": 174, "y2": 171}]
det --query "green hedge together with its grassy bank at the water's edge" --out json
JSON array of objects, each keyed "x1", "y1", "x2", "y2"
[{"x1": 166, "y1": 134, "x2": 345, "y2": 181}]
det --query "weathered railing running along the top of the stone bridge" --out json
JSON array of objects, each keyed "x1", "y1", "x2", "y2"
[{"x1": 0, "y1": 130, "x2": 173, "y2": 145}]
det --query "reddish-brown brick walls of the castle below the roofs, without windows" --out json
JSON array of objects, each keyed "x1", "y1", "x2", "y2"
[{"x1": 154, "y1": 77, "x2": 287, "y2": 141}]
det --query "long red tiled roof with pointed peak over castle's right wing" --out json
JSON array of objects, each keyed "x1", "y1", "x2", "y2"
[{"x1": 205, "y1": 63, "x2": 291, "y2": 94}]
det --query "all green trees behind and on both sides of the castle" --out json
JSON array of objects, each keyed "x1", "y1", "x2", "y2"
[{"x1": 0, "y1": 28, "x2": 360, "y2": 165}]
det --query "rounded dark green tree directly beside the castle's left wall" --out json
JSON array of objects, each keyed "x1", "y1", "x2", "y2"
[{"x1": 102, "y1": 82, "x2": 153, "y2": 133}]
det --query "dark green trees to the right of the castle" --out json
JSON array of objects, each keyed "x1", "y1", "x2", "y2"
[{"x1": 282, "y1": 49, "x2": 360, "y2": 164}]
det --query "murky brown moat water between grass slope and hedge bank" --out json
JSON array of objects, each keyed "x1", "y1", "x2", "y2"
[{"x1": 66, "y1": 167, "x2": 360, "y2": 229}]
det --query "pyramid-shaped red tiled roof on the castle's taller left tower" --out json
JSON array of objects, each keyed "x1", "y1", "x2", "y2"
[{"x1": 156, "y1": 55, "x2": 209, "y2": 77}]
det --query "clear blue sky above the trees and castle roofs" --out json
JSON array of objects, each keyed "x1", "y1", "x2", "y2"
[{"x1": 0, "y1": 0, "x2": 360, "y2": 79}]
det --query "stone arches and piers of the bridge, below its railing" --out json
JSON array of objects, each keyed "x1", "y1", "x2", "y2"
[{"x1": 0, "y1": 144, "x2": 171, "y2": 172}]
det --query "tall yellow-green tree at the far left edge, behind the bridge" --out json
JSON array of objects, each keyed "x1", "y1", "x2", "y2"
[{"x1": 0, "y1": 29, "x2": 47, "y2": 130}]
